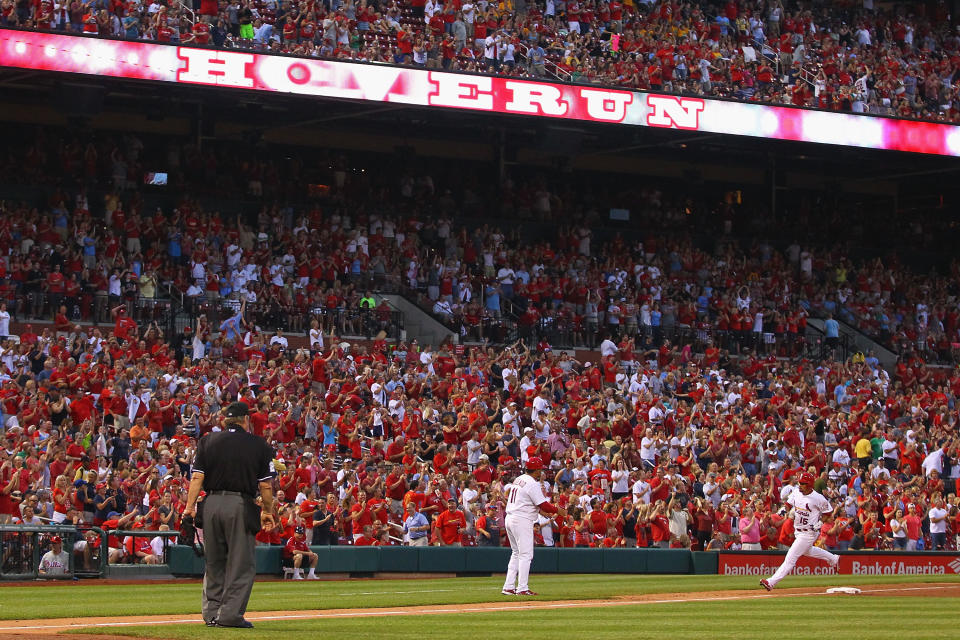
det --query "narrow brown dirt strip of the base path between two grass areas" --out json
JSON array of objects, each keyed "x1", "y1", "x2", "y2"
[{"x1": 0, "y1": 583, "x2": 960, "y2": 640}]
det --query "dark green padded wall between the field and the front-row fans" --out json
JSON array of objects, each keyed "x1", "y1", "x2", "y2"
[{"x1": 168, "y1": 545, "x2": 717, "y2": 576}]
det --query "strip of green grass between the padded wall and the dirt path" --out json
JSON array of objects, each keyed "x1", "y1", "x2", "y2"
[{"x1": 0, "y1": 575, "x2": 960, "y2": 620}]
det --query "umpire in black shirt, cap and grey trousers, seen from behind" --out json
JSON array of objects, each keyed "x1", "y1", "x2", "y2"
[{"x1": 183, "y1": 402, "x2": 276, "y2": 628}]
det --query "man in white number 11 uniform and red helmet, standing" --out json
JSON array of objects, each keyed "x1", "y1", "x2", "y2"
[{"x1": 501, "y1": 458, "x2": 565, "y2": 596}]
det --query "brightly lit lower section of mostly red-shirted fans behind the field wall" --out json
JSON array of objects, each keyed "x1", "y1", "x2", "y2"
[{"x1": 0, "y1": 328, "x2": 960, "y2": 548}]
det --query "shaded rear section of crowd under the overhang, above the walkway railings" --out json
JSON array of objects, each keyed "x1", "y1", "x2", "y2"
[{"x1": 0, "y1": 127, "x2": 960, "y2": 364}]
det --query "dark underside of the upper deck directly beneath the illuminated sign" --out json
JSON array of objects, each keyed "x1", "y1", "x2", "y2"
[{"x1": 0, "y1": 61, "x2": 960, "y2": 195}]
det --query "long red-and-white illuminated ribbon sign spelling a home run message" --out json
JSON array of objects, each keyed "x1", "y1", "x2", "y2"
[{"x1": 0, "y1": 30, "x2": 960, "y2": 156}]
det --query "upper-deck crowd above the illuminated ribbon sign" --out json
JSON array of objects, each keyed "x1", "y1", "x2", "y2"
[{"x1": 0, "y1": 0, "x2": 960, "y2": 121}]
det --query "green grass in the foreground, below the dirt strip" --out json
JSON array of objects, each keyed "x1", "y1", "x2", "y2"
[{"x1": 71, "y1": 596, "x2": 960, "y2": 640}]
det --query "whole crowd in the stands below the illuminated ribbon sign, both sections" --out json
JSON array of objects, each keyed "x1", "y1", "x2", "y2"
[{"x1": 0, "y1": 127, "x2": 960, "y2": 562}]
